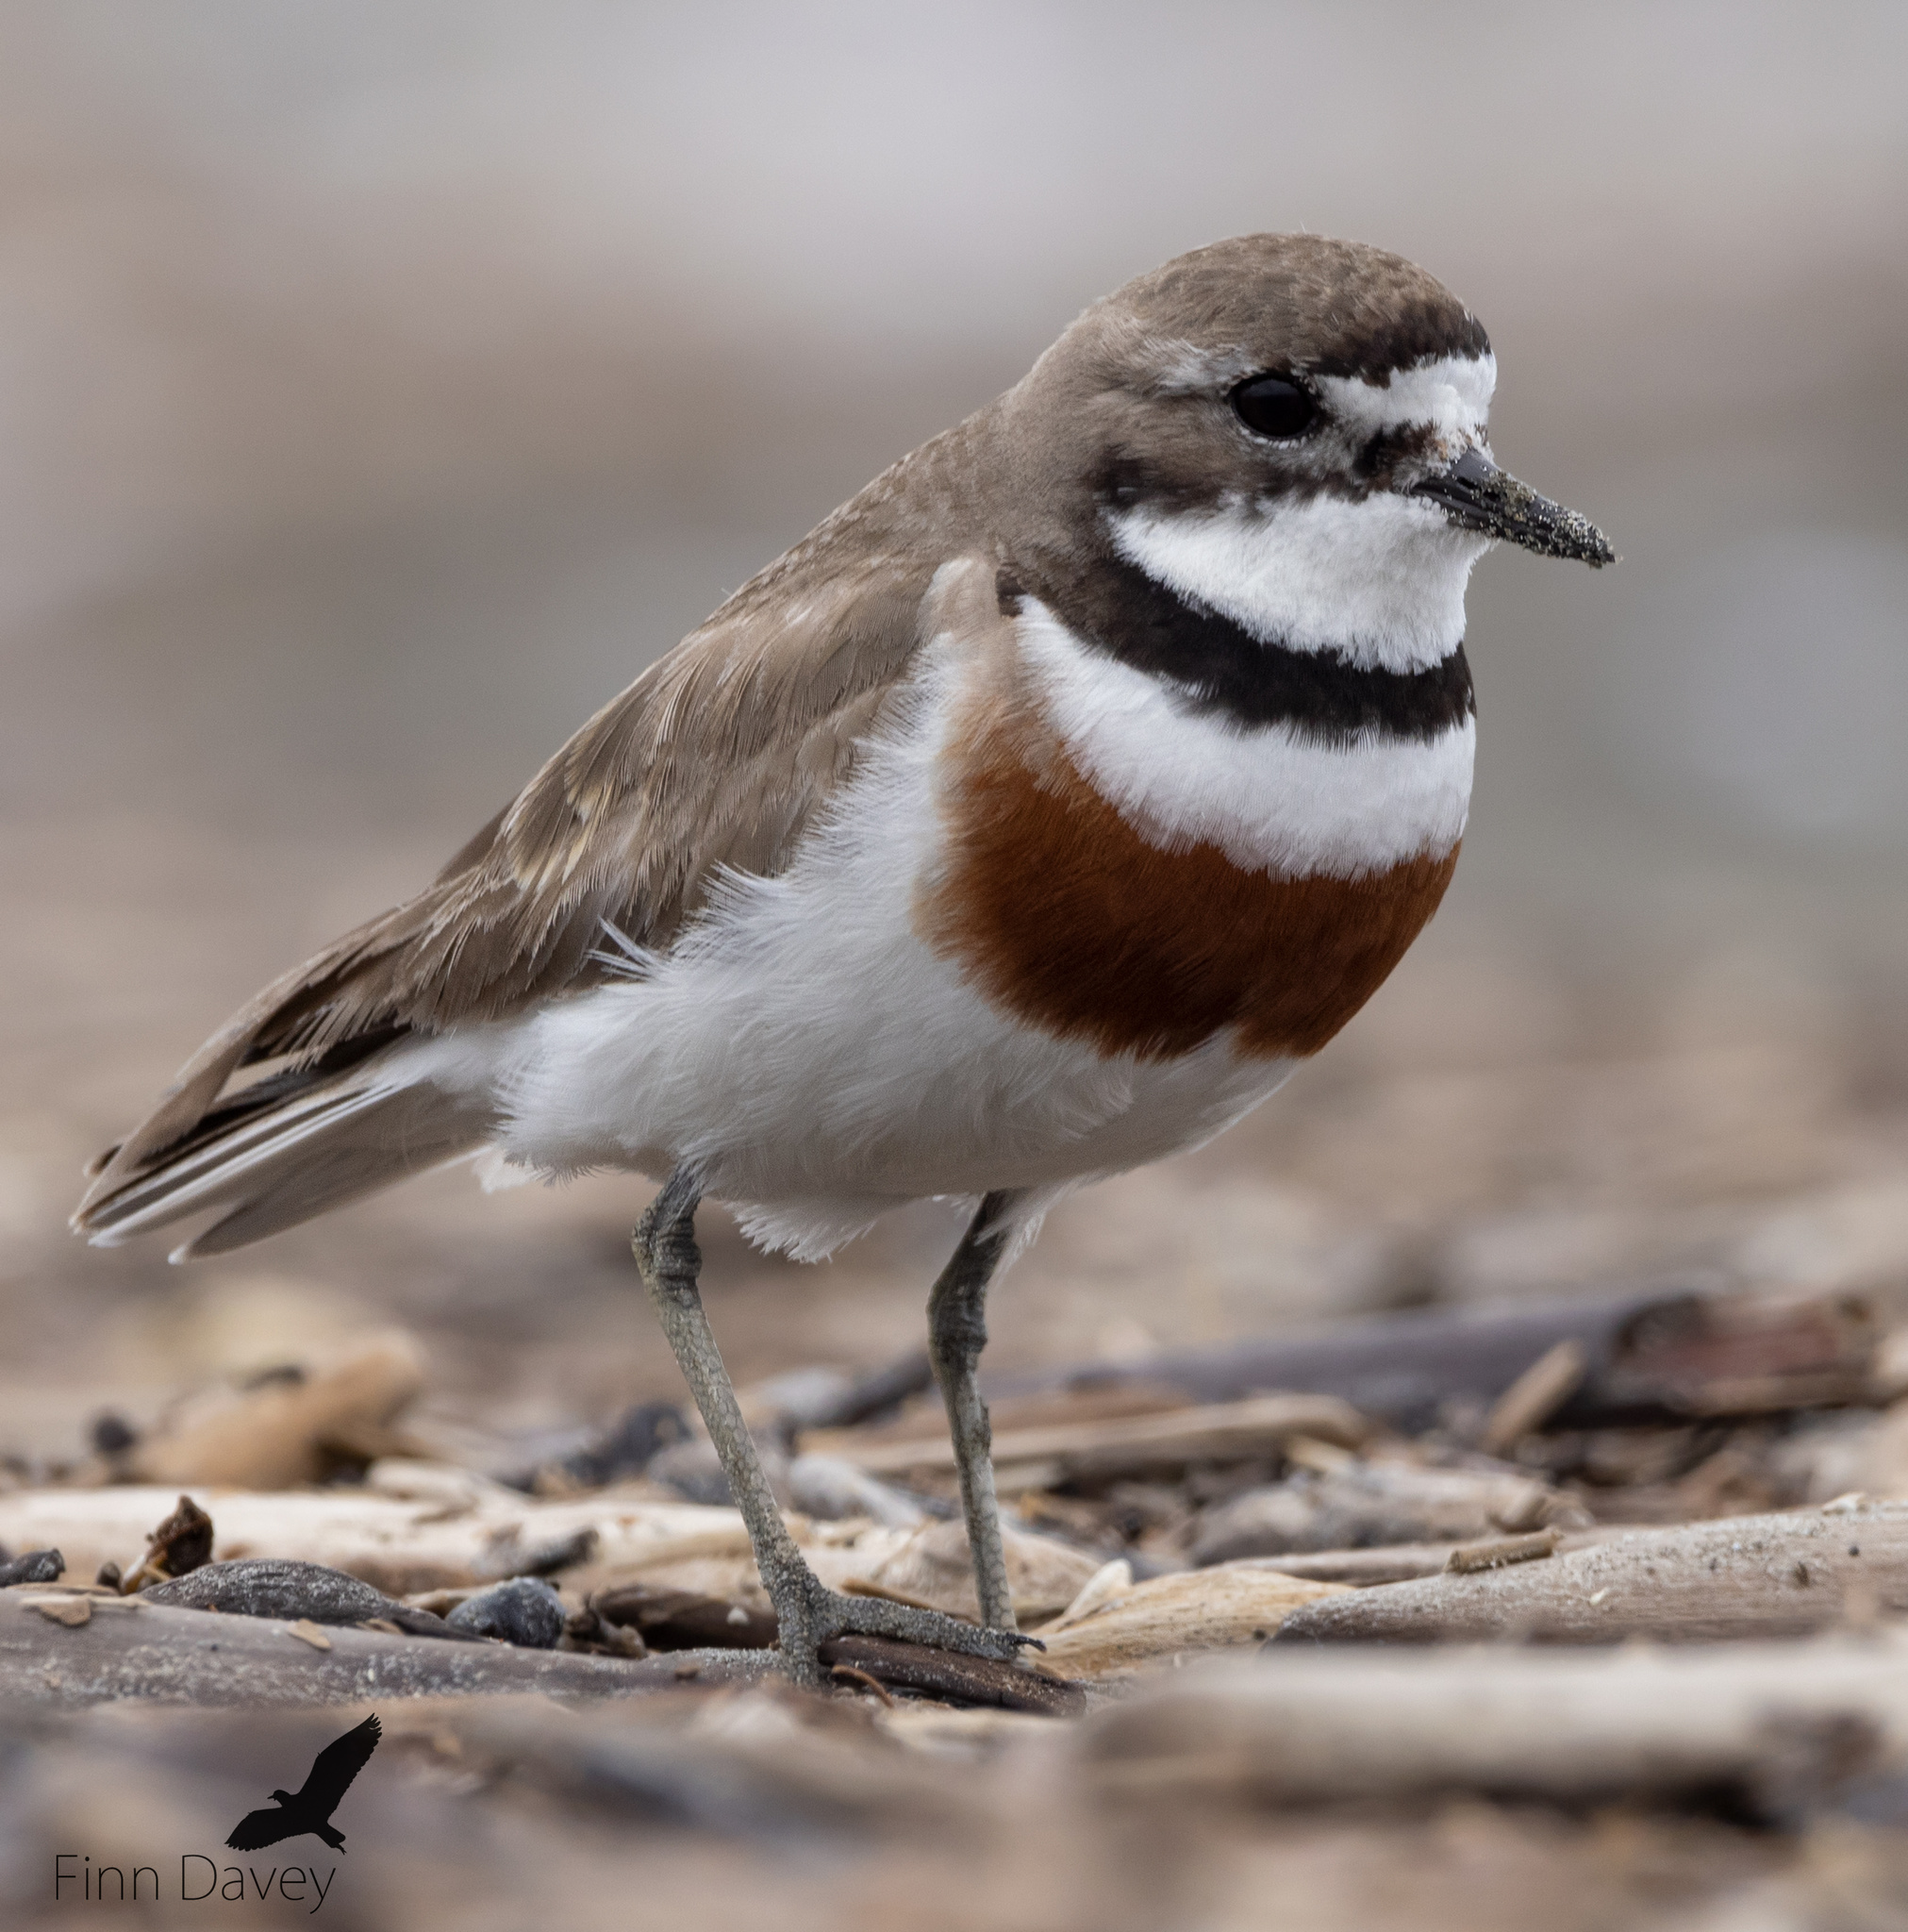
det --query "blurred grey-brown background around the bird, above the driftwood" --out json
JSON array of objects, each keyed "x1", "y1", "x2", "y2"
[{"x1": 0, "y1": 0, "x2": 1908, "y2": 1455}]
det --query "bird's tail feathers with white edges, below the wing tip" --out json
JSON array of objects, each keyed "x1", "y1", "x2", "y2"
[{"x1": 74, "y1": 1060, "x2": 496, "y2": 1259}]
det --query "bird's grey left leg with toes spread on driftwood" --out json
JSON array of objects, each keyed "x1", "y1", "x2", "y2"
[{"x1": 630, "y1": 1169, "x2": 1029, "y2": 1685}]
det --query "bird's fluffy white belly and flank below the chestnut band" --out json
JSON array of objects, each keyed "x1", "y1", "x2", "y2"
[{"x1": 484, "y1": 649, "x2": 1292, "y2": 1257}]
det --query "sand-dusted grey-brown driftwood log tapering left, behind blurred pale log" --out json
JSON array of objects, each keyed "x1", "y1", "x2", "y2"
[{"x1": 1276, "y1": 1503, "x2": 1908, "y2": 1646}]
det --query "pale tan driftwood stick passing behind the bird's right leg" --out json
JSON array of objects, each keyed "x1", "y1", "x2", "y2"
[{"x1": 802, "y1": 1395, "x2": 1369, "y2": 1488}]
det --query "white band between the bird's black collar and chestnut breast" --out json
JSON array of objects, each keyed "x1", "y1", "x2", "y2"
[{"x1": 1018, "y1": 599, "x2": 1477, "y2": 879}]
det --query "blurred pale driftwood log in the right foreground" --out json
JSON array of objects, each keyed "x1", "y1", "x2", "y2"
[{"x1": 1080, "y1": 1630, "x2": 1908, "y2": 1812}]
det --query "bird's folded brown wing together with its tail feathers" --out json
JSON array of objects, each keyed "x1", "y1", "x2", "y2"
[{"x1": 74, "y1": 552, "x2": 929, "y2": 1256}]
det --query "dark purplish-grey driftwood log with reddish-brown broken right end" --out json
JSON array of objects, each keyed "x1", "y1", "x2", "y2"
[{"x1": 988, "y1": 1289, "x2": 1881, "y2": 1432}]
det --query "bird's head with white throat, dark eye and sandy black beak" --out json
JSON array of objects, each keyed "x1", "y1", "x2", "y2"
[{"x1": 1004, "y1": 236, "x2": 1615, "y2": 671}]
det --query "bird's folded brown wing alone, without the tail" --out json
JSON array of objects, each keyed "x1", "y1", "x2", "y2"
[{"x1": 75, "y1": 539, "x2": 933, "y2": 1224}]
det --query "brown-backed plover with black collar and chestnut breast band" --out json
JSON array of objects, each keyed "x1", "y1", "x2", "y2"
[{"x1": 74, "y1": 234, "x2": 1615, "y2": 1683}]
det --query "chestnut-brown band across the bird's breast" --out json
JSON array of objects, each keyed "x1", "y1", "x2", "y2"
[{"x1": 916, "y1": 736, "x2": 1458, "y2": 1060}]
